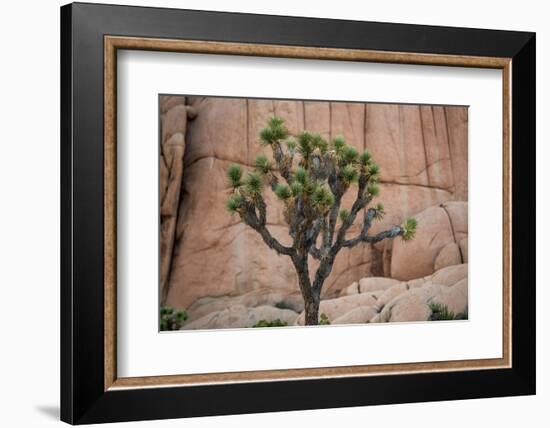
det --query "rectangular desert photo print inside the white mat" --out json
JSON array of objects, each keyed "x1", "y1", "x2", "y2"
[{"x1": 159, "y1": 94, "x2": 468, "y2": 331}]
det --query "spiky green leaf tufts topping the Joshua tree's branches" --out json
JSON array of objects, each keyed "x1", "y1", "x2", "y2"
[{"x1": 226, "y1": 116, "x2": 416, "y2": 236}]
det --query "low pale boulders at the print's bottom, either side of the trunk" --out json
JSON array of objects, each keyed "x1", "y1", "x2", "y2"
[{"x1": 182, "y1": 264, "x2": 468, "y2": 330}]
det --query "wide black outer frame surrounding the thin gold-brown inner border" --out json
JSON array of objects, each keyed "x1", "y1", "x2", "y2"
[{"x1": 61, "y1": 3, "x2": 536, "y2": 424}]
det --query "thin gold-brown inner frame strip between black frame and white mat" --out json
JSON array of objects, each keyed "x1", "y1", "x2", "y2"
[{"x1": 104, "y1": 35, "x2": 512, "y2": 391}]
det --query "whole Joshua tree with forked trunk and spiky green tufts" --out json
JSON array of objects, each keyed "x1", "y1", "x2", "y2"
[{"x1": 227, "y1": 117, "x2": 416, "y2": 325}]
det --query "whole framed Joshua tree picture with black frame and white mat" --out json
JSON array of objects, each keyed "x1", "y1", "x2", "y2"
[{"x1": 61, "y1": 3, "x2": 535, "y2": 424}]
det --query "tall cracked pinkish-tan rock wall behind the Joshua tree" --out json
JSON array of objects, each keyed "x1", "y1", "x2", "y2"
[{"x1": 160, "y1": 96, "x2": 468, "y2": 312}]
